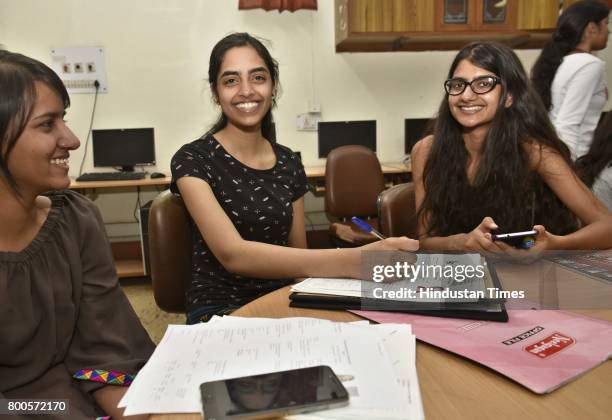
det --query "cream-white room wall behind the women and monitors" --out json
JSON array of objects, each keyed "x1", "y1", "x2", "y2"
[{"x1": 0, "y1": 0, "x2": 612, "y2": 240}]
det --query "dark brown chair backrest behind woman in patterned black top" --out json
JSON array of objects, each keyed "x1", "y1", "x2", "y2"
[{"x1": 149, "y1": 190, "x2": 192, "y2": 312}]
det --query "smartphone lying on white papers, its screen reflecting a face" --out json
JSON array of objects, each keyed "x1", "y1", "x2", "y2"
[{"x1": 200, "y1": 366, "x2": 349, "y2": 420}]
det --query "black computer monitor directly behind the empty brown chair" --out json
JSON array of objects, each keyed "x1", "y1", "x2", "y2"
[{"x1": 319, "y1": 120, "x2": 376, "y2": 158}]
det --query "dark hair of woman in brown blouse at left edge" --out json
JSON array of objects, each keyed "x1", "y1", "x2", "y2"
[{"x1": 0, "y1": 50, "x2": 70, "y2": 192}]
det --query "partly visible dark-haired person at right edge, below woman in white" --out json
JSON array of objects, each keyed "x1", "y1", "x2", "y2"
[{"x1": 576, "y1": 111, "x2": 612, "y2": 211}]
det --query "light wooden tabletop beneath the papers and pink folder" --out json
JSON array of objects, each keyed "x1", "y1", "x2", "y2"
[{"x1": 152, "y1": 278, "x2": 612, "y2": 420}]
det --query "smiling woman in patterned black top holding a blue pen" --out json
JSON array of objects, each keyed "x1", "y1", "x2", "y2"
[{"x1": 171, "y1": 33, "x2": 418, "y2": 323}]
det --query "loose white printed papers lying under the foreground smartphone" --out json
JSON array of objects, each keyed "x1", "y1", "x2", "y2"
[{"x1": 119, "y1": 317, "x2": 424, "y2": 419}]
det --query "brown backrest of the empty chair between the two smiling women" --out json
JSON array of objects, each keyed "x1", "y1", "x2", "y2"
[{"x1": 325, "y1": 145, "x2": 385, "y2": 218}]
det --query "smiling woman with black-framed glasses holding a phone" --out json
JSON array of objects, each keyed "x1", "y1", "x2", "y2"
[{"x1": 412, "y1": 42, "x2": 612, "y2": 255}]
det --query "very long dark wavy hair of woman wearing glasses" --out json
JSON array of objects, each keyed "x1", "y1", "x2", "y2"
[{"x1": 417, "y1": 42, "x2": 576, "y2": 240}]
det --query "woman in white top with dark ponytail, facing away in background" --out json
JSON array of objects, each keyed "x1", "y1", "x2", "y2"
[{"x1": 531, "y1": 0, "x2": 609, "y2": 160}]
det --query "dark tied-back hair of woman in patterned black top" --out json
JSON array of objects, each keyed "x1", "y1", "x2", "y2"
[{"x1": 206, "y1": 32, "x2": 280, "y2": 141}]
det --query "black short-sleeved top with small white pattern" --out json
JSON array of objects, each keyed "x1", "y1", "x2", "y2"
[{"x1": 170, "y1": 135, "x2": 308, "y2": 312}]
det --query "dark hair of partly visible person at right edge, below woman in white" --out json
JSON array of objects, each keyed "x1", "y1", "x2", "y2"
[{"x1": 576, "y1": 111, "x2": 612, "y2": 188}]
